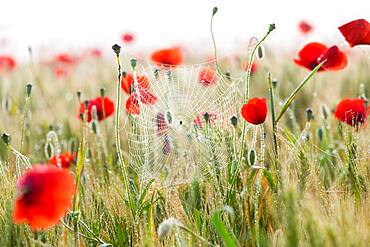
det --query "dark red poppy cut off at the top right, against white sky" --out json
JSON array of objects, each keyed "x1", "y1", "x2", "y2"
[{"x1": 338, "y1": 19, "x2": 370, "y2": 47}]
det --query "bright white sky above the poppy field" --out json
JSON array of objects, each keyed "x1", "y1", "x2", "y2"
[{"x1": 0, "y1": 0, "x2": 370, "y2": 56}]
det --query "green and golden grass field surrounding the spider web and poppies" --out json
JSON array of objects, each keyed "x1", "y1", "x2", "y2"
[{"x1": 0, "y1": 20, "x2": 370, "y2": 247}]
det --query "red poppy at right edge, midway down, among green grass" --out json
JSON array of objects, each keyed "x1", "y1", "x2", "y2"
[{"x1": 334, "y1": 99, "x2": 367, "y2": 126}]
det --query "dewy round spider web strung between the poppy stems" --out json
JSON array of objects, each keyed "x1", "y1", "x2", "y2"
[{"x1": 124, "y1": 52, "x2": 243, "y2": 185}]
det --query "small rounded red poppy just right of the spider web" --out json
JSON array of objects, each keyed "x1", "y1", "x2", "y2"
[{"x1": 241, "y1": 97, "x2": 267, "y2": 125}]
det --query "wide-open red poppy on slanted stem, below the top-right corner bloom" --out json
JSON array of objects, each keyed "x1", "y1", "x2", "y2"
[{"x1": 294, "y1": 42, "x2": 347, "y2": 71}]
